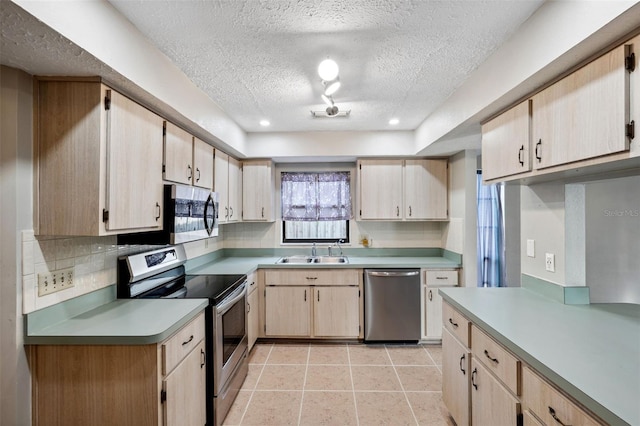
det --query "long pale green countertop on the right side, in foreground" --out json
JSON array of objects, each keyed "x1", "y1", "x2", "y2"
[{"x1": 439, "y1": 288, "x2": 640, "y2": 425}]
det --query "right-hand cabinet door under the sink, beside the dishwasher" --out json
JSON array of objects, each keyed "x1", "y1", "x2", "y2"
[{"x1": 313, "y1": 287, "x2": 360, "y2": 337}]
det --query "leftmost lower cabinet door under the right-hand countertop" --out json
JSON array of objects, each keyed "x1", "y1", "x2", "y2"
[{"x1": 442, "y1": 329, "x2": 472, "y2": 426}]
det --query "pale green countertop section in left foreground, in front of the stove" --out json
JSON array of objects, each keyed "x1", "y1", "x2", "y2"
[{"x1": 25, "y1": 299, "x2": 208, "y2": 345}]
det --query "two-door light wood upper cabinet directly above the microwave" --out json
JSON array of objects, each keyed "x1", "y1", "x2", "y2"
[{"x1": 162, "y1": 121, "x2": 213, "y2": 189}]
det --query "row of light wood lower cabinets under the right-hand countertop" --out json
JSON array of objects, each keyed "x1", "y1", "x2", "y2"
[{"x1": 442, "y1": 302, "x2": 605, "y2": 426}]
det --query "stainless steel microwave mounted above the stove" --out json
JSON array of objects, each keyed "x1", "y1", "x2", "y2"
[{"x1": 118, "y1": 184, "x2": 219, "y2": 244}]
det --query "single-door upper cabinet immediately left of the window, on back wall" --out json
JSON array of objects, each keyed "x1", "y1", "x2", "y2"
[{"x1": 242, "y1": 160, "x2": 275, "y2": 222}]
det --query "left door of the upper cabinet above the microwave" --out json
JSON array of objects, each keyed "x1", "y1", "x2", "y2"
[{"x1": 163, "y1": 121, "x2": 193, "y2": 185}]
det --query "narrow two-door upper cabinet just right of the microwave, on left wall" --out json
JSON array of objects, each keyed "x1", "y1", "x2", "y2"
[{"x1": 214, "y1": 150, "x2": 242, "y2": 223}]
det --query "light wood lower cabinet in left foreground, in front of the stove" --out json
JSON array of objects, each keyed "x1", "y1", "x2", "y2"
[{"x1": 29, "y1": 314, "x2": 207, "y2": 426}]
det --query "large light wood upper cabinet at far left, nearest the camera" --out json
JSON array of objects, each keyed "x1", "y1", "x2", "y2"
[{"x1": 34, "y1": 79, "x2": 163, "y2": 235}]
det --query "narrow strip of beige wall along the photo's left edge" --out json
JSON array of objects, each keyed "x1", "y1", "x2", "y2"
[{"x1": 0, "y1": 66, "x2": 33, "y2": 425}]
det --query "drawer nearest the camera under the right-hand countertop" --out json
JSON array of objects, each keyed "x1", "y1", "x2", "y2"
[{"x1": 522, "y1": 366, "x2": 600, "y2": 426}]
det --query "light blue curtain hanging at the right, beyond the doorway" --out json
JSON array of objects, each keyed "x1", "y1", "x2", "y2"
[{"x1": 477, "y1": 172, "x2": 505, "y2": 287}]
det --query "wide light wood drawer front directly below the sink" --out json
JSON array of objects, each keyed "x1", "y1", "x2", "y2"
[{"x1": 264, "y1": 269, "x2": 362, "y2": 286}]
